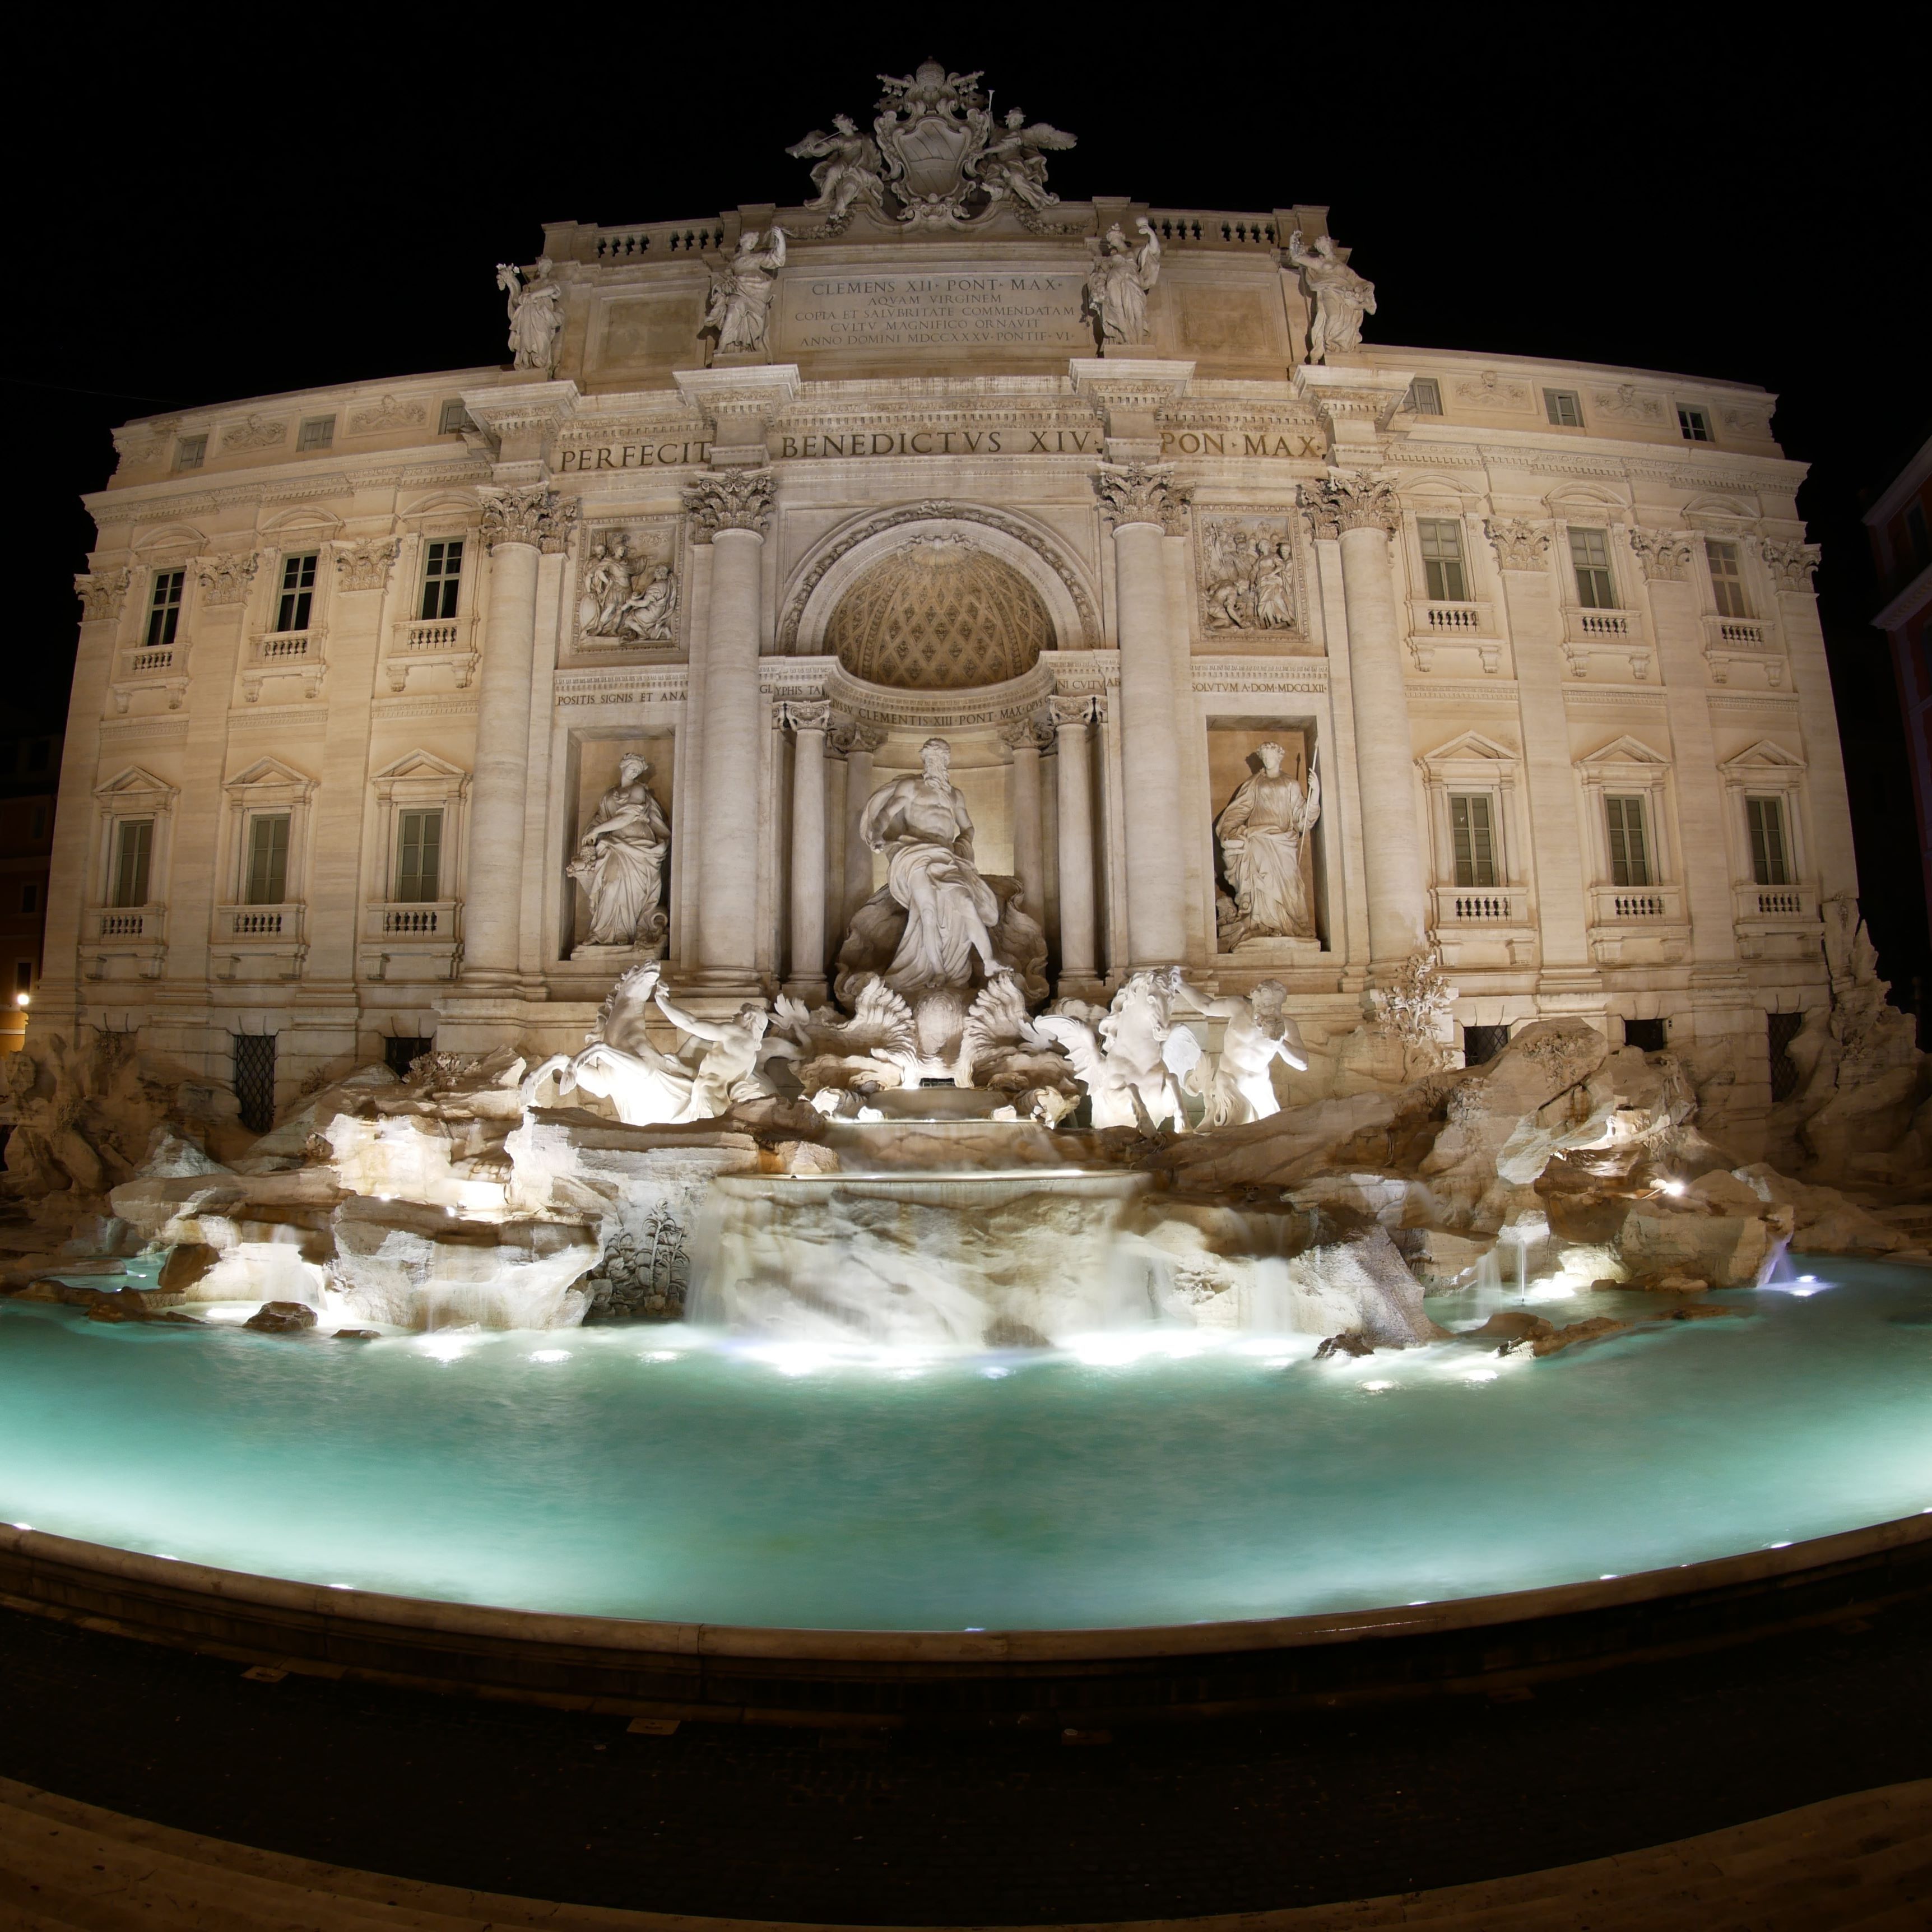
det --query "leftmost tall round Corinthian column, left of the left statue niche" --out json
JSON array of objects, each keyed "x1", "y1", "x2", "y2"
[{"x1": 464, "y1": 485, "x2": 578, "y2": 987}]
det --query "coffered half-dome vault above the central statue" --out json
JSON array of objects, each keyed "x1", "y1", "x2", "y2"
[{"x1": 825, "y1": 535, "x2": 1055, "y2": 691}]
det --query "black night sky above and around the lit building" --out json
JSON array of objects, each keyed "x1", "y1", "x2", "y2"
[{"x1": 15, "y1": 24, "x2": 1932, "y2": 1001}]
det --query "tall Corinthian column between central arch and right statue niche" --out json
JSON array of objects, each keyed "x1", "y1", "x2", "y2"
[{"x1": 1097, "y1": 464, "x2": 1188, "y2": 968}]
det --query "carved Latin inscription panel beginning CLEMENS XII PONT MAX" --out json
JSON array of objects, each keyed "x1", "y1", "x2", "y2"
[{"x1": 775, "y1": 268, "x2": 1094, "y2": 355}]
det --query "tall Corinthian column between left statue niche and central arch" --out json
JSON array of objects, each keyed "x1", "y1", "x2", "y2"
[{"x1": 684, "y1": 470, "x2": 771, "y2": 993}]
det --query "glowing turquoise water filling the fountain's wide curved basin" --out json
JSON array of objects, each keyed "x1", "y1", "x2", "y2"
[{"x1": 0, "y1": 1262, "x2": 1932, "y2": 1631}]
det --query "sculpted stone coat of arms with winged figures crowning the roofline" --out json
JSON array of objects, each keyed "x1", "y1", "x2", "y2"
[{"x1": 786, "y1": 60, "x2": 1074, "y2": 234}]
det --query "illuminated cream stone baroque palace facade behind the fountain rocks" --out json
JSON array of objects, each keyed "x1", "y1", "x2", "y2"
[{"x1": 33, "y1": 69, "x2": 1857, "y2": 1134}]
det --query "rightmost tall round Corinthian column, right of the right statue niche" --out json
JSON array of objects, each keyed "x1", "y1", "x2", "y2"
[{"x1": 1302, "y1": 470, "x2": 1428, "y2": 982}]
